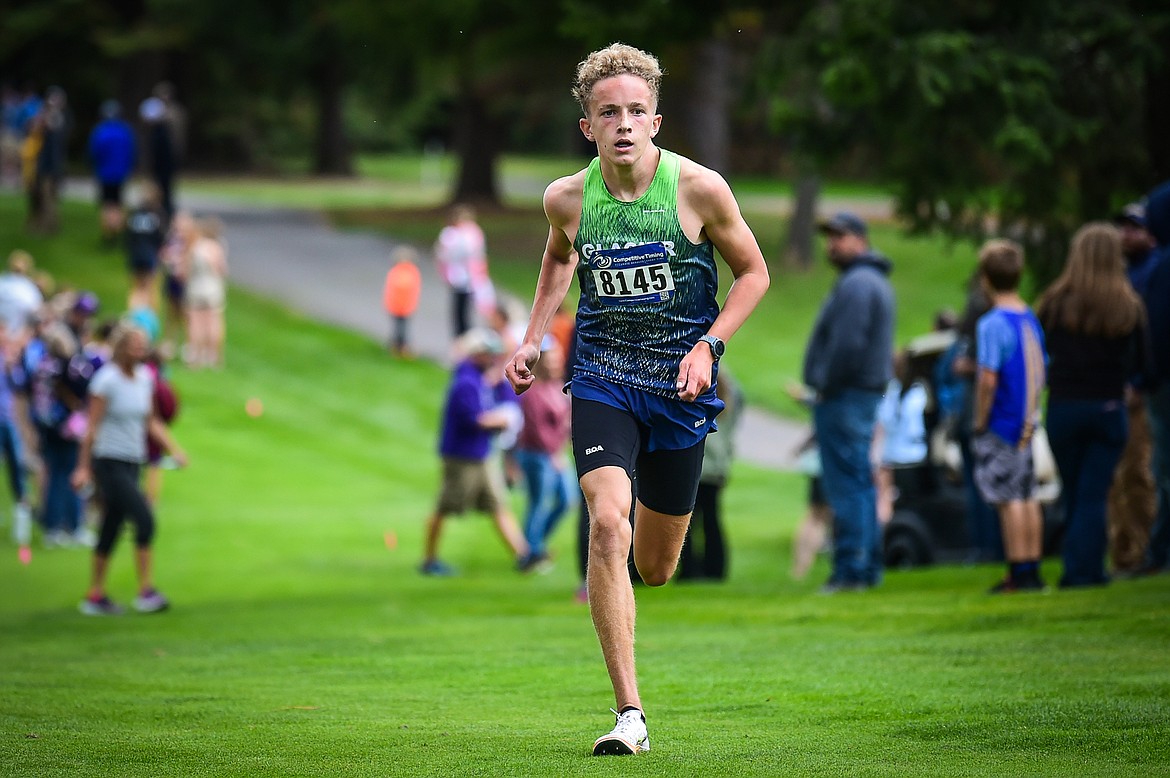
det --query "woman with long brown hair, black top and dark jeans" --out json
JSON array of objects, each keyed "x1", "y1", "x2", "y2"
[{"x1": 1037, "y1": 221, "x2": 1147, "y2": 587}]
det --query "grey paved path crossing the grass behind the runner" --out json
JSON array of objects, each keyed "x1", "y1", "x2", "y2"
[{"x1": 78, "y1": 182, "x2": 806, "y2": 469}]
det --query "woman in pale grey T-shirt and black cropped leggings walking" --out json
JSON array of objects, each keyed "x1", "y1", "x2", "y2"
[{"x1": 73, "y1": 325, "x2": 187, "y2": 615}]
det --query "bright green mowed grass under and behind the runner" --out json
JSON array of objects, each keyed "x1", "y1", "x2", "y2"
[{"x1": 0, "y1": 200, "x2": 1170, "y2": 777}]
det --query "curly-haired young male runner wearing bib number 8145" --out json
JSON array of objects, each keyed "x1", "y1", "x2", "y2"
[{"x1": 505, "y1": 43, "x2": 769, "y2": 755}]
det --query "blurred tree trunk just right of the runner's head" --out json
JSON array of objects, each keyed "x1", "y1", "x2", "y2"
[{"x1": 687, "y1": 37, "x2": 731, "y2": 175}]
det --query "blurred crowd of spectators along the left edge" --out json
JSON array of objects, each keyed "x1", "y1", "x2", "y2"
[{"x1": 0, "y1": 83, "x2": 216, "y2": 615}]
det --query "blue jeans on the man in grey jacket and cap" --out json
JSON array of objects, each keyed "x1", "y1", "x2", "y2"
[{"x1": 813, "y1": 390, "x2": 882, "y2": 586}]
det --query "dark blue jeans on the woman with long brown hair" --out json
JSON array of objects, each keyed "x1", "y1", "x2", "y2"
[{"x1": 1047, "y1": 399, "x2": 1129, "y2": 586}]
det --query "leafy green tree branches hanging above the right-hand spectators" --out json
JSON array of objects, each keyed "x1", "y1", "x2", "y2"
[{"x1": 777, "y1": 0, "x2": 1170, "y2": 278}]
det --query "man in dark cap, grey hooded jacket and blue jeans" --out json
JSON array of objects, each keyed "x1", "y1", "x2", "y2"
[{"x1": 804, "y1": 213, "x2": 894, "y2": 593}]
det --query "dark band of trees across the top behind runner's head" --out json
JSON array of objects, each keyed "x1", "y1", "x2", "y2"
[{"x1": 0, "y1": 0, "x2": 1170, "y2": 243}]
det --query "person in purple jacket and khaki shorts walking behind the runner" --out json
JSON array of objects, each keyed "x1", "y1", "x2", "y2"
[{"x1": 419, "y1": 329, "x2": 528, "y2": 576}]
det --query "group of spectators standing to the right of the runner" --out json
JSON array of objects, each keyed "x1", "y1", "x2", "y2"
[{"x1": 793, "y1": 183, "x2": 1170, "y2": 593}]
